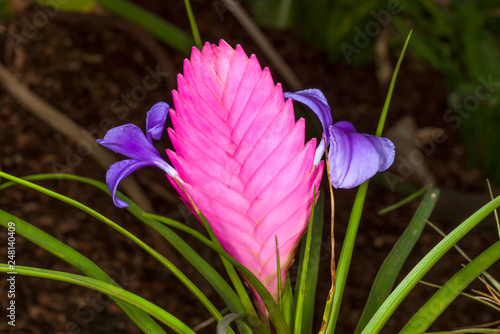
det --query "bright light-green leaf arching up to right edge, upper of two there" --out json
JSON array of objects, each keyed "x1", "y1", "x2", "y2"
[{"x1": 362, "y1": 196, "x2": 500, "y2": 334}]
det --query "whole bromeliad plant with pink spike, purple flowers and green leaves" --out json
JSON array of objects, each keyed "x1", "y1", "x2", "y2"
[{"x1": 0, "y1": 34, "x2": 500, "y2": 334}]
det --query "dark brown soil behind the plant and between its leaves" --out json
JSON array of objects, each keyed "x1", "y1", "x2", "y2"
[{"x1": 0, "y1": 1, "x2": 500, "y2": 334}]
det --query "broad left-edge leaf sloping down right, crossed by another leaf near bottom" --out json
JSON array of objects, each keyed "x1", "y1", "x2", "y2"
[{"x1": 0, "y1": 213, "x2": 165, "y2": 333}]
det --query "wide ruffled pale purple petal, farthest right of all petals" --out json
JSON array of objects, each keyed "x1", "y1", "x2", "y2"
[{"x1": 328, "y1": 122, "x2": 394, "y2": 189}]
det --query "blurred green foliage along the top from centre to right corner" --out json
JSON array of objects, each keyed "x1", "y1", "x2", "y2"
[{"x1": 247, "y1": 0, "x2": 500, "y2": 184}]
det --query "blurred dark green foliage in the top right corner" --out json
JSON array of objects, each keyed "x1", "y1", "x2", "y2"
[{"x1": 395, "y1": 0, "x2": 500, "y2": 183}]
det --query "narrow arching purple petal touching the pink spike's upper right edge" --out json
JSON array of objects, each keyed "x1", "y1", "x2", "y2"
[{"x1": 283, "y1": 89, "x2": 333, "y2": 143}]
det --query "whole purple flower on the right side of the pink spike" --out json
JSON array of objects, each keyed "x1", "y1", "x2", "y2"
[{"x1": 284, "y1": 89, "x2": 395, "y2": 189}]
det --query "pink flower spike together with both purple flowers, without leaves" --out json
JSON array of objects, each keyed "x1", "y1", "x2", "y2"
[{"x1": 98, "y1": 40, "x2": 394, "y2": 319}]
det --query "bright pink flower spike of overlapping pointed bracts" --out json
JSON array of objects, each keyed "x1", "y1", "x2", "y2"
[{"x1": 167, "y1": 41, "x2": 323, "y2": 306}]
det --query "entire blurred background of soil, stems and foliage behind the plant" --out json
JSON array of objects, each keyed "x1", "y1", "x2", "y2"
[{"x1": 0, "y1": 0, "x2": 500, "y2": 333}]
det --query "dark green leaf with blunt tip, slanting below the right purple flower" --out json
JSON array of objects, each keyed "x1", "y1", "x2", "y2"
[{"x1": 355, "y1": 189, "x2": 439, "y2": 333}]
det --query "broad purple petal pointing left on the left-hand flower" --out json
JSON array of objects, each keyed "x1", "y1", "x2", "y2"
[{"x1": 97, "y1": 124, "x2": 161, "y2": 161}]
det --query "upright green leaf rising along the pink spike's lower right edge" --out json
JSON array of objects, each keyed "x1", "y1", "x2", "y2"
[{"x1": 294, "y1": 192, "x2": 325, "y2": 334}]
